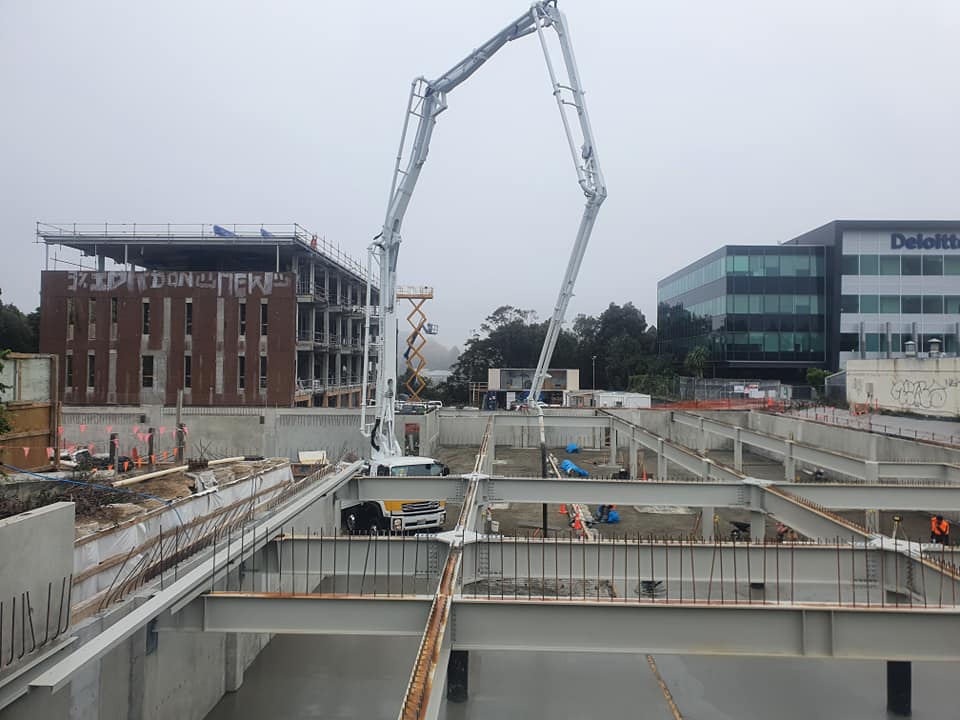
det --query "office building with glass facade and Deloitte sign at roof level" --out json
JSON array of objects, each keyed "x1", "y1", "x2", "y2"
[{"x1": 657, "y1": 220, "x2": 960, "y2": 381}]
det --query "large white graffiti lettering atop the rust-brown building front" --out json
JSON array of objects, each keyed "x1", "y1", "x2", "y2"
[{"x1": 67, "y1": 270, "x2": 292, "y2": 298}]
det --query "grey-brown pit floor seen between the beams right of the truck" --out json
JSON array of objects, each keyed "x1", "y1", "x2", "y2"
[{"x1": 437, "y1": 447, "x2": 930, "y2": 542}]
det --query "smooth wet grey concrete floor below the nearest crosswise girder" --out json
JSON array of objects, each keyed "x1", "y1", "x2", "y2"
[{"x1": 207, "y1": 635, "x2": 960, "y2": 720}]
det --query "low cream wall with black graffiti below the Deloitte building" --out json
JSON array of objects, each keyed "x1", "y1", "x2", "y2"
[{"x1": 847, "y1": 357, "x2": 960, "y2": 418}]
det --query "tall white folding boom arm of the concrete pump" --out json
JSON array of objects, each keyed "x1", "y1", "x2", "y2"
[{"x1": 361, "y1": 0, "x2": 607, "y2": 459}]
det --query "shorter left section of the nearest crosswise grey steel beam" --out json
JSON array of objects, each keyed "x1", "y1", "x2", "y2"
[{"x1": 202, "y1": 593, "x2": 433, "y2": 637}]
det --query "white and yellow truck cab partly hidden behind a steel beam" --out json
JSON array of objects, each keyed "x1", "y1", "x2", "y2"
[{"x1": 341, "y1": 456, "x2": 450, "y2": 534}]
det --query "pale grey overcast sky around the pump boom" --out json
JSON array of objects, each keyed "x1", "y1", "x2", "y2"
[{"x1": 0, "y1": 0, "x2": 960, "y2": 345}]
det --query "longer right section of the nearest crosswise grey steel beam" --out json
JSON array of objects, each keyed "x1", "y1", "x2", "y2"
[{"x1": 452, "y1": 600, "x2": 960, "y2": 662}]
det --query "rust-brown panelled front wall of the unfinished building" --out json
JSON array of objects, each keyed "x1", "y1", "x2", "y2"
[{"x1": 40, "y1": 271, "x2": 296, "y2": 406}]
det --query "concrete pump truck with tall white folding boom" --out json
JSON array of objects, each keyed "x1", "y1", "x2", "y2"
[{"x1": 343, "y1": 0, "x2": 607, "y2": 532}]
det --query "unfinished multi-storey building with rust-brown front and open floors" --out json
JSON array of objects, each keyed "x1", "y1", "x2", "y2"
[{"x1": 37, "y1": 223, "x2": 376, "y2": 407}]
